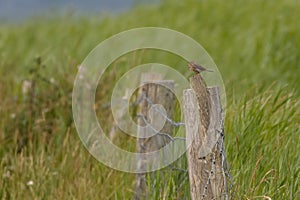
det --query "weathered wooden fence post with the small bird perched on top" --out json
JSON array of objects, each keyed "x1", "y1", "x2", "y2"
[{"x1": 183, "y1": 74, "x2": 228, "y2": 200}]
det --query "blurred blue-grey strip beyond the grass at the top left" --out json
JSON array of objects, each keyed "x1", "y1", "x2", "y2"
[{"x1": 0, "y1": 0, "x2": 159, "y2": 21}]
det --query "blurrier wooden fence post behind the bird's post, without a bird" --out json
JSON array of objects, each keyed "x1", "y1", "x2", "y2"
[{"x1": 134, "y1": 73, "x2": 175, "y2": 200}]
